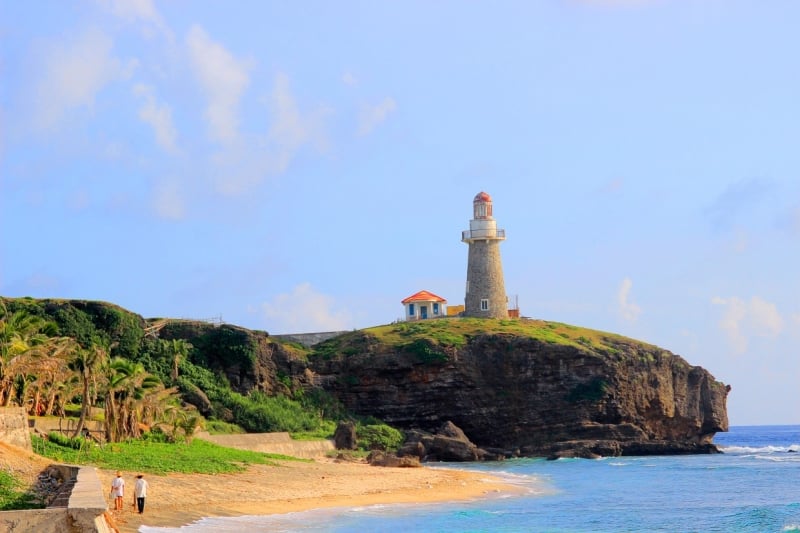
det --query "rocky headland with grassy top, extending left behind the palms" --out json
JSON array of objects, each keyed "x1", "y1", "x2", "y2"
[{"x1": 0, "y1": 298, "x2": 730, "y2": 457}]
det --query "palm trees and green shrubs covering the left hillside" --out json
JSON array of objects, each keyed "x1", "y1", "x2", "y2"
[{"x1": 0, "y1": 298, "x2": 342, "y2": 442}]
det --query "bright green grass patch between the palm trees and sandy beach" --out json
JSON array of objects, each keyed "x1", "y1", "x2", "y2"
[{"x1": 31, "y1": 435, "x2": 300, "y2": 474}]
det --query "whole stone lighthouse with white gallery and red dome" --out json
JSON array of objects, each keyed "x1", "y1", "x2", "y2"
[{"x1": 461, "y1": 192, "x2": 508, "y2": 318}]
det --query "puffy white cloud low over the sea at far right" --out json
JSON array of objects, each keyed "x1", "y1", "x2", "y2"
[{"x1": 711, "y1": 296, "x2": 784, "y2": 354}]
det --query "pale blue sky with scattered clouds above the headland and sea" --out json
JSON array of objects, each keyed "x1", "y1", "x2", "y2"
[{"x1": 0, "y1": 0, "x2": 800, "y2": 425}]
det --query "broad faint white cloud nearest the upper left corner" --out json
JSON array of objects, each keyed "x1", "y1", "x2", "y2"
[{"x1": 34, "y1": 29, "x2": 137, "y2": 130}]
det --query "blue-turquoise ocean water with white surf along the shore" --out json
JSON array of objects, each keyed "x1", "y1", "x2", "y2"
[{"x1": 139, "y1": 426, "x2": 800, "y2": 533}]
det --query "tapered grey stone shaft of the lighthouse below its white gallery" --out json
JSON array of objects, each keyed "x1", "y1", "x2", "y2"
[{"x1": 464, "y1": 240, "x2": 508, "y2": 318}]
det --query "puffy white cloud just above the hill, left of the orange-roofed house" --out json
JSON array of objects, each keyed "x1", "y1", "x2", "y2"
[{"x1": 262, "y1": 282, "x2": 352, "y2": 334}]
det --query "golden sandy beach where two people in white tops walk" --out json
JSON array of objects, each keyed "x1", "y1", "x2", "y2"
[{"x1": 98, "y1": 459, "x2": 522, "y2": 533}]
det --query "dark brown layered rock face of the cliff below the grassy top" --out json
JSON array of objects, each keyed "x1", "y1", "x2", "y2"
[{"x1": 311, "y1": 333, "x2": 730, "y2": 456}]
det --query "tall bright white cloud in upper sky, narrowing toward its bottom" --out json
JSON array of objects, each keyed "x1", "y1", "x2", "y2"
[{"x1": 186, "y1": 25, "x2": 250, "y2": 143}]
